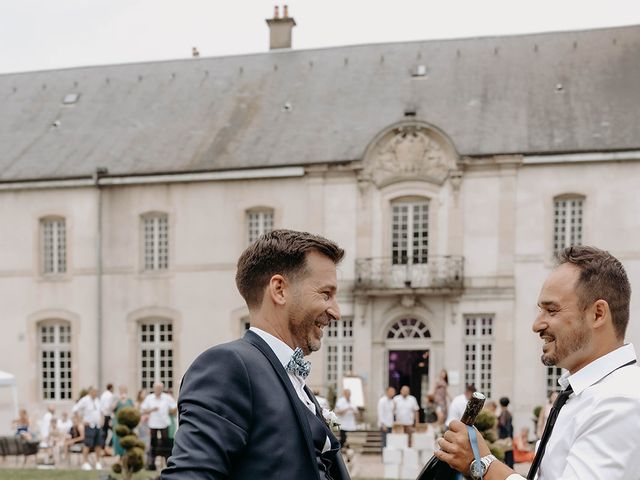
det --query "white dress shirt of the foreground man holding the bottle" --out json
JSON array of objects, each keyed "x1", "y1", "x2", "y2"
[{"x1": 508, "y1": 344, "x2": 640, "y2": 480}]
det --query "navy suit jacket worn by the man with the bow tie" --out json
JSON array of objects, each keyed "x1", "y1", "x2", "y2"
[{"x1": 162, "y1": 331, "x2": 349, "y2": 480}]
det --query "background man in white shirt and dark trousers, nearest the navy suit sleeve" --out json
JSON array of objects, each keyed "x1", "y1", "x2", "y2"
[{"x1": 140, "y1": 382, "x2": 177, "y2": 470}]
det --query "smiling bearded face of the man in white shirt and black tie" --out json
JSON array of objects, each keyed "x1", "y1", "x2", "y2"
[{"x1": 533, "y1": 263, "x2": 593, "y2": 373}]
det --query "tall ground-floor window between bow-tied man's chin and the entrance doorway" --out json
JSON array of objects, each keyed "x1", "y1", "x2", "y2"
[{"x1": 325, "y1": 318, "x2": 353, "y2": 392}]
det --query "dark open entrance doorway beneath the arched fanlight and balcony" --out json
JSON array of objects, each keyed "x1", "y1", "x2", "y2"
[{"x1": 389, "y1": 350, "x2": 429, "y2": 421}]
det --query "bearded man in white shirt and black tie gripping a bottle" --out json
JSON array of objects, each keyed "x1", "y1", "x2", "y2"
[{"x1": 436, "y1": 246, "x2": 640, "y2": 480}]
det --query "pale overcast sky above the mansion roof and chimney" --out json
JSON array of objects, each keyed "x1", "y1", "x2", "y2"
[{"x1": 0, "y1": 0, "x2": 640, "y2": 73}]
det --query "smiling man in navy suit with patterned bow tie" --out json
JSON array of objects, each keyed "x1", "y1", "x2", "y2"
[{"x1": 162, "y1": 230, "x2": 349, "y2": 480}]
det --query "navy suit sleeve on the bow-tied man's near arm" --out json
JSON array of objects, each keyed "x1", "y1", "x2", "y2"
[{"x1": 161, "y1": 347, "x2": 252, "y2": 480}]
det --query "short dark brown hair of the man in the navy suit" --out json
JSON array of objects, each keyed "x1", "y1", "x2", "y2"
[{"x1": 236, "y1": 230, "x2": 344, "y2": 308}]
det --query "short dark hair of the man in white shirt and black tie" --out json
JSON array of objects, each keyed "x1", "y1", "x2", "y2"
[{"x1": 558, "y1": 245, "x2": 631, "y2": 339}]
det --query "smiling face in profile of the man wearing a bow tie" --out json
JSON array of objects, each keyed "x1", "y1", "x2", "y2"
[{"x1": 288, "y1": 251, "x2": 340, "y2": 355}]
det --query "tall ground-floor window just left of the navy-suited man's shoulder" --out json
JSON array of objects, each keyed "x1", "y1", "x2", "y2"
[{"x1": 138, "y1": 319, "x2": 173, "y2": 390}]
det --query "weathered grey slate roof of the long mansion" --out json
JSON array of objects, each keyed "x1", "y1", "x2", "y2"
[{"x1": 0, "y1": 26, "x2": 640, "y2": 181}]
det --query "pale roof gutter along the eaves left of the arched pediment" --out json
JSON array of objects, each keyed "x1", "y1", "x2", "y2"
[{"x1": 0, "y1": 167, "x2": 305, "y2": 191}]
